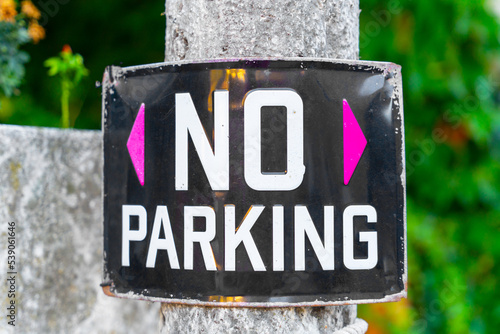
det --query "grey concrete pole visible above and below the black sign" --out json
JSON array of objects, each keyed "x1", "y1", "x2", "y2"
[{"x1": 160, "y1": 0, "x2": 368, "y2": 334}]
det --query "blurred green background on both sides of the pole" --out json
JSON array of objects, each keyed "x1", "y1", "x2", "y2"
[{"x1": 0, "y1": 0, "x2": 500, "y2": 334}]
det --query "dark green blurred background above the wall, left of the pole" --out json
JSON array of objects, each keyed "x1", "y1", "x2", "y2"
[{"x1": 0, "y1": 0, "x2": 165, "y2": 129}]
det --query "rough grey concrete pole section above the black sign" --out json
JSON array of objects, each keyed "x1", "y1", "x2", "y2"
[{"x1": 165, "y1": 0, "x2": 359, "y2": 61}]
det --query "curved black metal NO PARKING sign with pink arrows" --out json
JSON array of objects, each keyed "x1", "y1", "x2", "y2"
[{"x1": 103, "y1": 59, "x2": 406, "y2": 306}]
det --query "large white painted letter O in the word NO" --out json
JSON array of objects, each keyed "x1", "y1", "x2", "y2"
[{"x1": 244, "y1": 89, "x2": 305, "y2": 191}]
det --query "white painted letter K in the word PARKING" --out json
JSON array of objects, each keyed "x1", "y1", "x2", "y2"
[{"x1": 224, "y1": 205, "x2": 266, "y2": 271}]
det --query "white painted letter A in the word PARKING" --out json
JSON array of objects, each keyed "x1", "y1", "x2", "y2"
[{"x1": 146, "y1": 205, "x2": 180, "y2": 269}]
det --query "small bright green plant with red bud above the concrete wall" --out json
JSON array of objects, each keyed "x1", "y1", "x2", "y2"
[{"x1": 44, "y1": 45, "x2": 89, "y2": 128}]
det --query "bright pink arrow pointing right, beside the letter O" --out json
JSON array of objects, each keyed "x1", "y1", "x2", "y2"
[{"x1": 344, "y1": 99, "x2": 366, "y2": 185}]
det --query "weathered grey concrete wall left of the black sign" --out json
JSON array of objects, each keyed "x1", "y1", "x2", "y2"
[{"x1": 0, "y1": 125, "x2": 159, "y2": 333}]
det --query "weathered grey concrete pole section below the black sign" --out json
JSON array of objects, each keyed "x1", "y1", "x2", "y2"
[{"x1": 160, "y1": 304, "x2": 368, "y2": 334}]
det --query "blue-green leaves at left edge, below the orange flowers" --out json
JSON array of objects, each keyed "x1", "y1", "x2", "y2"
[{"x1": 0, "y1": 21, "x2": 30, "y2": 97}]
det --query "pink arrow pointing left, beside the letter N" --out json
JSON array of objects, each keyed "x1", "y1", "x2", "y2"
[{"x1": 127, "y1": 103, "x2": 145, "y2": 186}]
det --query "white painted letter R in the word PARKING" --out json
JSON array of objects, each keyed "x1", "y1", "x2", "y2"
[{"x1": 184, "y1": 206, "x2": 217, "y2": 271}]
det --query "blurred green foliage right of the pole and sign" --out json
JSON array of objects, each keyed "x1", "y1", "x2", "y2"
[{"x1": 360, "y1": 0, "x2": 500, "y2": 333}]
